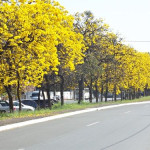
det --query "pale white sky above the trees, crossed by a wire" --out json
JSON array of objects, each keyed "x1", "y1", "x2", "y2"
[{"x1": 56, "y1": 0, "x2": 150, "y2": 52}]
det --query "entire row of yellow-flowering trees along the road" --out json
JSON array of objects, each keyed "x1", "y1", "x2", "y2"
[{"x1": 0, "y1": 0, "x2": 150, "y2": 111}]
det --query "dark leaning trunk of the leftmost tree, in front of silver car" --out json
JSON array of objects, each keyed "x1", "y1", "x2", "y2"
[{"x1": 4, "y1": 86, "x2": 14, "y2": 113}]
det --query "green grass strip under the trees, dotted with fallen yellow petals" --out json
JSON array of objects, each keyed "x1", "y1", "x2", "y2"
[{"x1": 0, "y1": 96, "x2": 150, "y2": 120}]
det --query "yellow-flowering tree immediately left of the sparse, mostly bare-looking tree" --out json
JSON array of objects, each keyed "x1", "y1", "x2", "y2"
[{"x1": 57, "y1": 16, "x2": 84, "y2": 105}]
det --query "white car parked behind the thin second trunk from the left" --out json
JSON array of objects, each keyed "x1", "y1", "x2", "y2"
[{"x1": 13, "y1": 101, "x2": 35, "y2": 111}]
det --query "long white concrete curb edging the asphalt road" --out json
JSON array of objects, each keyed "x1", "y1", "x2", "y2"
[{"x1": 0, "y1": 101, "x2": 150, "y2": 132}]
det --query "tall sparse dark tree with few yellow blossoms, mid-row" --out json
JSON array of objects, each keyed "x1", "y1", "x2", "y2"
[{"x1": 74, "y1": 11, "x2": 108, "y2": 103}]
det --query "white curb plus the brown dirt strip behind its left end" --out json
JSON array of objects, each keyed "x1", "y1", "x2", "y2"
[{"x1": 0, "y1": 101, "x2": 150, "y2": 131}]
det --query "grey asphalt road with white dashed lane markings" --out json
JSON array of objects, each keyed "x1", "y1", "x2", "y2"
[{"x1": 0, "y1": 104, "x2": 150, "y2": 150}]
